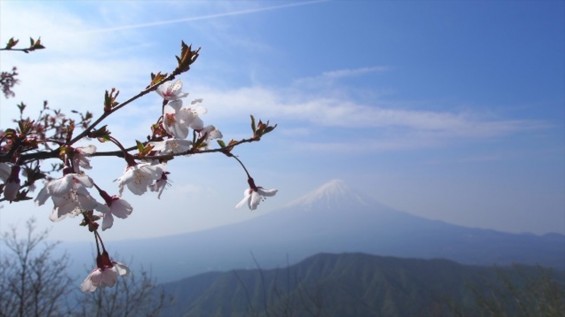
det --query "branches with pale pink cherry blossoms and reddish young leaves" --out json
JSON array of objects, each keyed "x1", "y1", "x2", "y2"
[{"x1": 0, "y1": 39, "x2": 277, "y2": 292}]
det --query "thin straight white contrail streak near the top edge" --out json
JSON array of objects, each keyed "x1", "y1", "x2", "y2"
[{"x1": 80, "y1": 0, "x2": 329, "y2": 34}]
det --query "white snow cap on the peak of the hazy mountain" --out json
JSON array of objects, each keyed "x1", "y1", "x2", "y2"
[{"x1": 290, "y1": 179, "x2": 369, "y2": 209}]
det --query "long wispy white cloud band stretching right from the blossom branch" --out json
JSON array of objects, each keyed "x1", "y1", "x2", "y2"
[{"x1": 197, "y1": 87, "x2": 547, "y2": 138}]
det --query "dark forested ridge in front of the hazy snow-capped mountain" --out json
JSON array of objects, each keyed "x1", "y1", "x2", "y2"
[{"x1": 159, "y1": 253, "x2": 565, "y2": 317}]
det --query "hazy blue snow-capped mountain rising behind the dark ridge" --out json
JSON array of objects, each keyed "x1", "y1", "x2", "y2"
[{"x1": 87, "y1": 180, "x2": 565, "y2": 282}]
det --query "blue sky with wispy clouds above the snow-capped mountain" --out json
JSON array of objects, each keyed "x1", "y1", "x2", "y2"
[{"x1": 0, "y1": 1, "x2": 565, "y2": 239}]
